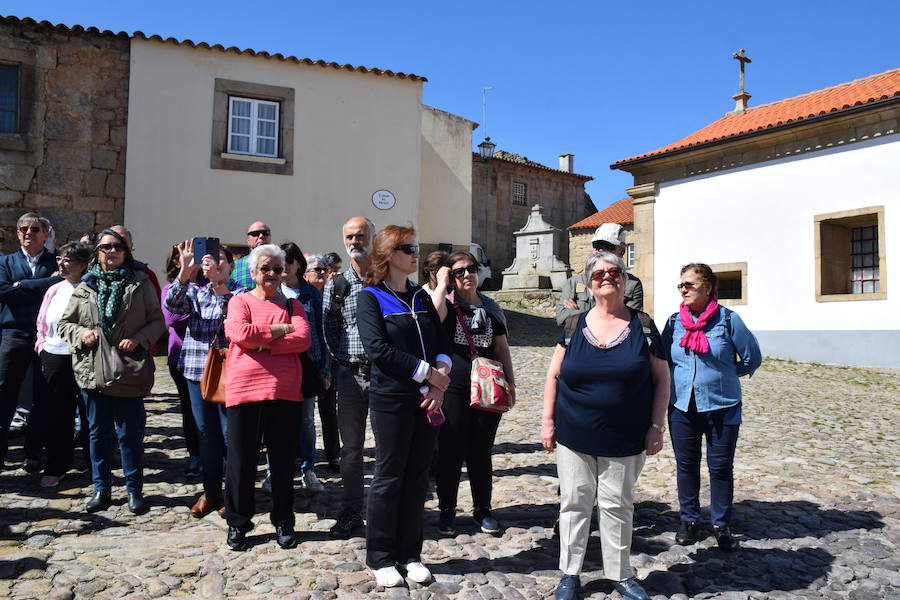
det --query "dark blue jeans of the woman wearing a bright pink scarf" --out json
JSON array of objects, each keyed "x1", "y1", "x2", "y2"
[{"x1": 669, "y1": 402, "x2": 741, "y2": 527}]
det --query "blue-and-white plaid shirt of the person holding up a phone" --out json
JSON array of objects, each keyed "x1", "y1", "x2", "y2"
[{"x1": 166, "y1": 279, "x2": 247, "y2": 381}]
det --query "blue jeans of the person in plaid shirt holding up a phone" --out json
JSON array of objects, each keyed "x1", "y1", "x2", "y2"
[{"x1": 186, "y1": 379, "x2": 228, "y2": 499}]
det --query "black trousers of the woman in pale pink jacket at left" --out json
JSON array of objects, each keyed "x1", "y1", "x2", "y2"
[{"x1": 25, "y1": 352, "x2": 81, "y2": 475}]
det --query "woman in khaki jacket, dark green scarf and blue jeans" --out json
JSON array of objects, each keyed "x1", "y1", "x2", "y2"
[{"x1": 57, "y1": 229, "x2": 166, "y2": 514}]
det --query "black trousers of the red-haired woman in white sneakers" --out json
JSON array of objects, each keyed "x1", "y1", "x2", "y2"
[{"x1": 366, "y1": 400, "x2": 438, "y2": 569}]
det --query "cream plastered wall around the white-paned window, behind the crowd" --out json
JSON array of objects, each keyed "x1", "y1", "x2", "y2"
[{"x1": 125, "y1": 39, "x2": 426, "y2": 272}]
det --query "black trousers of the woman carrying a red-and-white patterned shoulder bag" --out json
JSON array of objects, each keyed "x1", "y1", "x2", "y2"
[{"x1": 436, "y1": 390, "x2": 502, "y2": 510}]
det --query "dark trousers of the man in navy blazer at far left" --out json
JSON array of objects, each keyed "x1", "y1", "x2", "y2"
[{"x1": 0, "y1": 329, "x2": 41, "y2": 464}]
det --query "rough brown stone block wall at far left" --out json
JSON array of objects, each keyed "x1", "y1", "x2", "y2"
[{"x1": 0, "y1": 18, "x2": 130, "y2": 252}]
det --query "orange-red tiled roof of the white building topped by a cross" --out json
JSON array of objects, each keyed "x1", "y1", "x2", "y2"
[{"x1": 609, "y1": 68, "x2": 900, "y2": 170}]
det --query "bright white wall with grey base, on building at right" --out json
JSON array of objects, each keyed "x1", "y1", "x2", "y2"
[{"x1": 654, "y1": 136, "x2": 900, "y2": 366}]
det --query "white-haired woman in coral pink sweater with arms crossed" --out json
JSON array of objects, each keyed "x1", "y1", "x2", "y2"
[{"x1": 225, "y1": 244, "x2": 311, "y2": 551}]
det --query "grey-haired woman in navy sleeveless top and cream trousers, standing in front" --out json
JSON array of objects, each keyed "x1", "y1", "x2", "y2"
[{"x1": 541, "y1": 251, "x2": 669, "y2": 600}]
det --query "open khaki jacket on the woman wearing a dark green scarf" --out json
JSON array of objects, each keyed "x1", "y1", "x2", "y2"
[{"x1": 56, "y1": 271, "x2": 166, "y2": 393}]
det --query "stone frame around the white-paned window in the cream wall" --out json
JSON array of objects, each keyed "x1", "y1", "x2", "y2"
[{"x1": 209, "y1": 77, "x2": 294, "y2": 175}]
